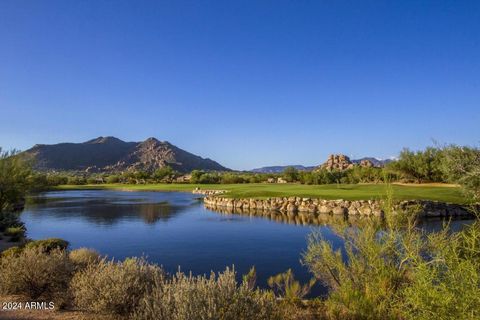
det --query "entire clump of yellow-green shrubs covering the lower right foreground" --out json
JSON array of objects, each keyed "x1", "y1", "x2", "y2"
[{"x1": 304, "y1": 192, "x2": 480, "y2": 319}]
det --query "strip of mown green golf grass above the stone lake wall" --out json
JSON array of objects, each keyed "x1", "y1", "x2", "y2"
[{"x1": 57, "y1": 183, "x2": 465, "y2": 203}]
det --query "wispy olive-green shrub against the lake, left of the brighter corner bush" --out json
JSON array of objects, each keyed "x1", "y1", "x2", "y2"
[{"x1": 304, "y1": 227, "x2": 406, "y2": 319}]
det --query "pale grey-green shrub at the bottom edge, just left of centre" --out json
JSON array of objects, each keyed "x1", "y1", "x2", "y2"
[{"x1": 134, "y1": 269, "x2": 279, "y2": 320}]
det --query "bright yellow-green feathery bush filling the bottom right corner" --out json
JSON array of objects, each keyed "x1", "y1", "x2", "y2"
[{"x1": 400, "y1": 220, "x2": 480, "y2": 320}]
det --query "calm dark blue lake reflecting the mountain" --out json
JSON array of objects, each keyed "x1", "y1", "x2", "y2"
[{"x1": 22, "y1": 190, "x2": 472, "y2": 295}]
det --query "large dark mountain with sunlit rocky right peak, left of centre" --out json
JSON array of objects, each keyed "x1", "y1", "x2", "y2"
[{"x1": 22, "y1": 137, "x2": 230, "y2": 172}]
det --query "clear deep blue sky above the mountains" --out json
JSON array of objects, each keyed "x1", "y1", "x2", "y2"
[{"x1": 0, "y1": 0, "x2": 480, "y2": 169}]
